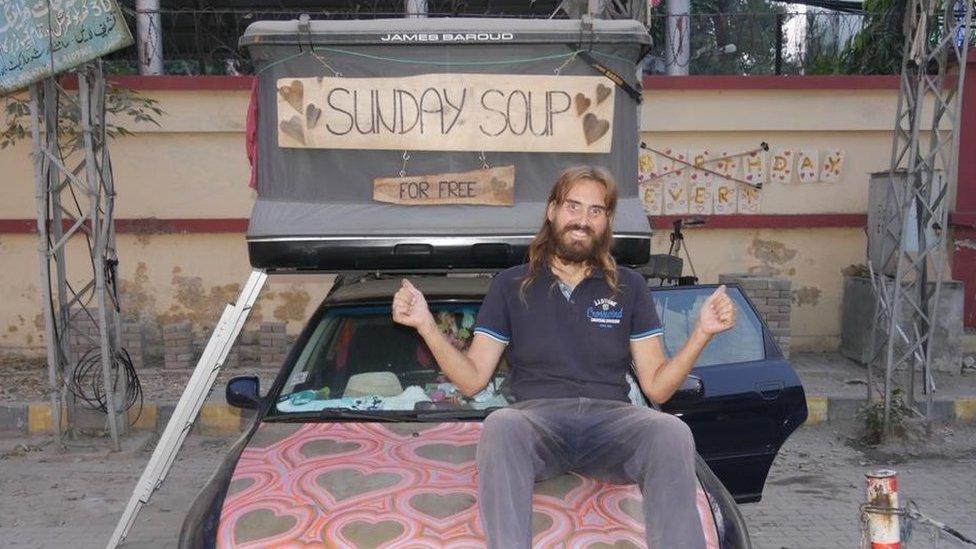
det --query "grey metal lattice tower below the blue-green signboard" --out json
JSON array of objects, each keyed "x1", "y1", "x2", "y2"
[{"x1": 30, "y1": 60, "x2": 127, "y2": 451}]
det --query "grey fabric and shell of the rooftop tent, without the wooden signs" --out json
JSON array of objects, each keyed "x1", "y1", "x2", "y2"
[{"x1": 241, "y1": 18, "x2": 650, "y2": 268}]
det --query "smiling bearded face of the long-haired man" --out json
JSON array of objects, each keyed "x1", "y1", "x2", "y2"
[{"x1": 546, "y1": 179, "x2": 610, "y2": 263}]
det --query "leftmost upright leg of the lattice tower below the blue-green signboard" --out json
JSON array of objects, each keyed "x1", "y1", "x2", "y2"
[{"x1": 30, "y1": 78, "x2": 64, "y2": 452}]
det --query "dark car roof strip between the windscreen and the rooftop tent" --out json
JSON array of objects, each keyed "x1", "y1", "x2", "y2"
[{"x1": 325, "y1": 274, "x2": 491, "y2": 305}]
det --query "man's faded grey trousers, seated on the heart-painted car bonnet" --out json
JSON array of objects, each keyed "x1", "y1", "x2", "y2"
[{"x1": 477, "y1": 398, "x2": 705, "y2": 549}]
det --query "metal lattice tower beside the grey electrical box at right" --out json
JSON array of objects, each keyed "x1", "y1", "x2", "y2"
[{"x1": 867, "y1": 0, "x2": 973, "y2": 437}]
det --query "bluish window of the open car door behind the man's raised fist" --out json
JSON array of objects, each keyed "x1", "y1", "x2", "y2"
[{"x1": 651, "y1": 287, "x2": 766, "y2": 366}]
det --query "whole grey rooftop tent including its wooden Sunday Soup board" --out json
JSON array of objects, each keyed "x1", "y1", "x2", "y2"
[{"x1": 241, "y1": 18, "x2": 650, "y2": 270}]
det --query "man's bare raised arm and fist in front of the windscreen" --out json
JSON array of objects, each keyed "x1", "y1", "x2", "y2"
[{"x1": 393, "y1": 279, "x2": 505, "y2": 396}]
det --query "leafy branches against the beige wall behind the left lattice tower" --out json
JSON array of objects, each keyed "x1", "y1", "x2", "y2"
[{"x1": 0, "y1": 83, "x2": 164, "y2": 150}]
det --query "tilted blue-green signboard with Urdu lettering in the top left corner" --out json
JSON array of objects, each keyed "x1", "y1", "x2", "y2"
[{"x1": 0, "y1": 0, "x2": 132, "y2": 93}]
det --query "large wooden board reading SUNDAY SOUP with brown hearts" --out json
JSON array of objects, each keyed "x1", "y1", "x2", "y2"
[{"x1": 277, "y1": 74, "x2": 614, "y2": 153}]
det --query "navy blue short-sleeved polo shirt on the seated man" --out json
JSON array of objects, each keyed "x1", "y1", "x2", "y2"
[{"x1": 474, "y1": 265, "x2": 663, "y2": 402}]
